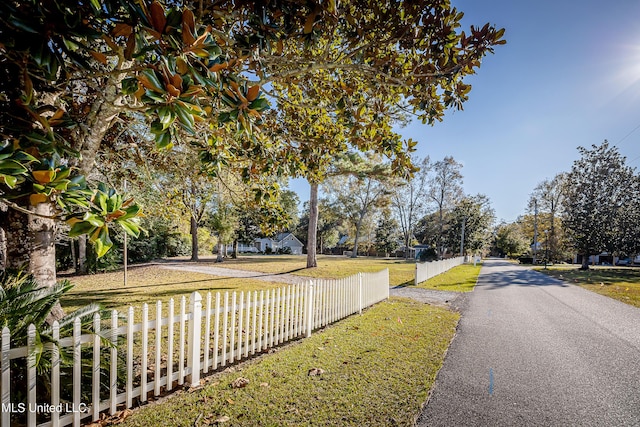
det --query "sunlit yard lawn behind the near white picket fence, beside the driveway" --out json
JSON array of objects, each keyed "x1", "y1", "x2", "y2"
[{"x1": 61, "y1": 255, "x2": 415, "y2": 320}]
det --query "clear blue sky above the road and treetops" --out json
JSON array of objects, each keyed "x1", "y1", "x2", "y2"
[{"x1": 291, "y1": 0, "x2": 640, "y2": 221}]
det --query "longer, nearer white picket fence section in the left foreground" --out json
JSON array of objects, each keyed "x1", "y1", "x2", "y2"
[{"x1": 0, "y1": 270, "x2": 389, "y2": 427}]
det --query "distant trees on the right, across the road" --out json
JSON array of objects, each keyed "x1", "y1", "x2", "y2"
[{"x1": 494, "y1": 140, "x2": 640, "y2": 269}]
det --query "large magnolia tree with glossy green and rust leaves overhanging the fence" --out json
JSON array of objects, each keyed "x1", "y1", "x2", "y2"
[{"x1": 0, "y1": 0, "x2": 504, "y2": 298}]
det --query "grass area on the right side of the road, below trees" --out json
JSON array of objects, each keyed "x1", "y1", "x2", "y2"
[{"x1": 536, "y1": 265, "x2": 640, "y2": 307}]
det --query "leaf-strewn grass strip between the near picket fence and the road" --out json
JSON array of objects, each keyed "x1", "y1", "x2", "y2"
[{"x1": 123, "y1": 299, "x2": 459, "y2": 426}]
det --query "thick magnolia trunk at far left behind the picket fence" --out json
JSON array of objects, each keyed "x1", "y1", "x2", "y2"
[{"x1": 0, "y1": 203, "x2": 64, "y2": 324}]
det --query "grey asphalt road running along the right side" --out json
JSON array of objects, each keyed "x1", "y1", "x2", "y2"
[{"x1": 418, "y1": 260, "x2": 640, "y2": 426}]
